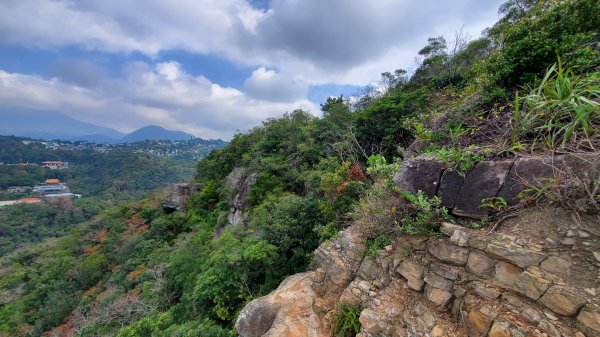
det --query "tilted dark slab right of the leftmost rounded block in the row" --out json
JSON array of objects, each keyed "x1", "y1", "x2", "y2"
[{"x1": 452, "y1": 160, "x2": 513, "y2": 219}]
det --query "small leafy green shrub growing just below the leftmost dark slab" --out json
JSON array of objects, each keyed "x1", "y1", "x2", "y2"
[{"x1": 401, "y1": 191, "x2": 452, "y2": 235}]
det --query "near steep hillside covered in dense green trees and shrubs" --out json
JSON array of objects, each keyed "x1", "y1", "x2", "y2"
[{"x1": 0, "y1": 0, "x2": 600, "y2": 337}]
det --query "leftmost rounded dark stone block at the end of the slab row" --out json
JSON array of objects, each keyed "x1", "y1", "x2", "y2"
[{"x1": 392, "y1": 154, "x2": 446, "y2": 196}]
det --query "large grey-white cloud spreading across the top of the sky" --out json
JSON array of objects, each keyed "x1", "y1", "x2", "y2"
[{"x1": 0, "y1": 0, "x2": 502, "y2": 84}]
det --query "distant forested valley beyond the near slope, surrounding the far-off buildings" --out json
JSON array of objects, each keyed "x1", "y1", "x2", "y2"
[{"x1": 0, "y1": 136, "x2": 193, "y2": 256}]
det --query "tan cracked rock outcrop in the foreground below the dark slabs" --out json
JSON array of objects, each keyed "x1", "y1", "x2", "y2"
[{"x1": 236, "y1": 207, "x2": 600, "y2": 337}]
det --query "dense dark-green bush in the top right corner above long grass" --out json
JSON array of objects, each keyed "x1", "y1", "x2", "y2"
[{"x1": 485, "y1": 0, "x2": 600, "y2": 88}]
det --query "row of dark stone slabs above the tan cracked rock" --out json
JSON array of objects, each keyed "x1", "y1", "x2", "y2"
[{"x1": 394, "y1": 153, "x2": 600, "y2": 219}]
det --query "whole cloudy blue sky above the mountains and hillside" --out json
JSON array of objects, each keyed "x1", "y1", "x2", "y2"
[{"x1": 0, "y1": 0, "x2": 503, "y2": 139}]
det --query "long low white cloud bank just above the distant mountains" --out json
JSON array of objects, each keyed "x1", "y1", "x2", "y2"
[{"x1": 0, "y1": 62, "x2": 318, "y2": 139}]
